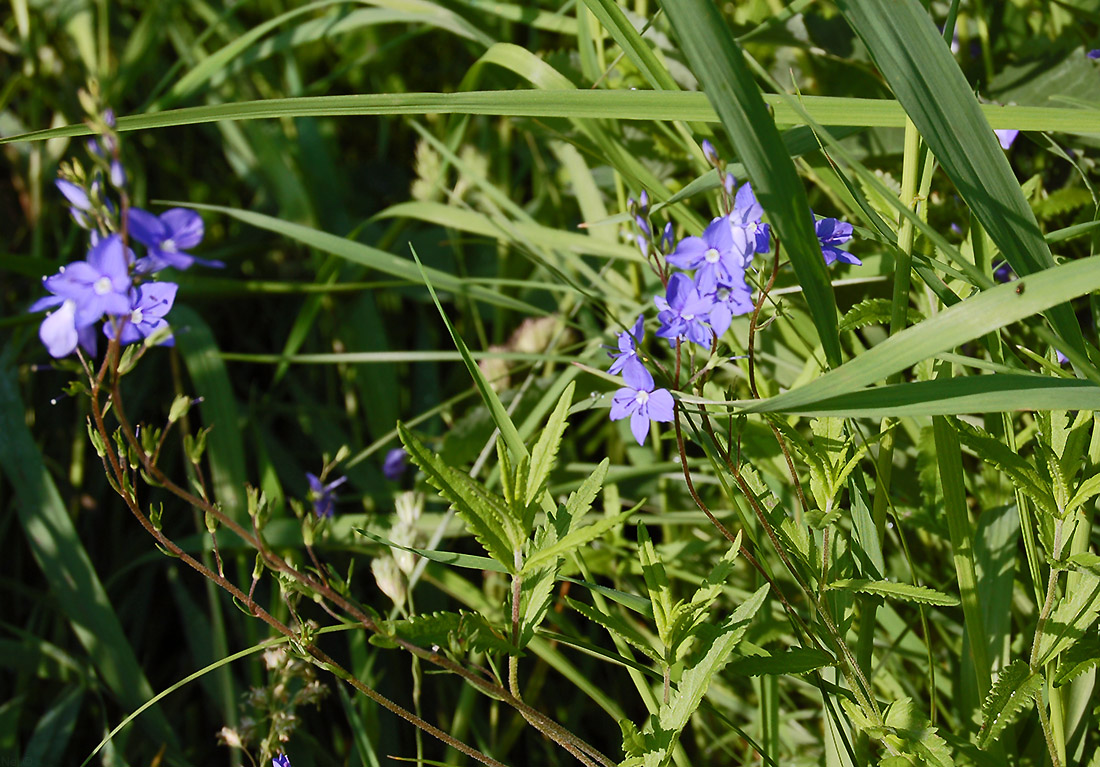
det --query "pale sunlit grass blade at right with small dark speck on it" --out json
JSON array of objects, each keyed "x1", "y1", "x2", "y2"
[{"x1": 745, "y1": 256, "x2": 1100, "y2": 413}]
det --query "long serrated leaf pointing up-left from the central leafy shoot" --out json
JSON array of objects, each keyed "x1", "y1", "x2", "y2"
[{"x1": 397, "y1": 423, "x2": 521, "y2": 572}]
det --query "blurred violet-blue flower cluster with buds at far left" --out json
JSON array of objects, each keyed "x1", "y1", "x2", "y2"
[{"x1": 30, "y1": 126, "x2": 224, "y2": 358}]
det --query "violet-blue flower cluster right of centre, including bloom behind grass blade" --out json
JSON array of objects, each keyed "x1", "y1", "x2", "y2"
[{"x1": 608, "y1": 141, "x2": 862, "y2": 445}]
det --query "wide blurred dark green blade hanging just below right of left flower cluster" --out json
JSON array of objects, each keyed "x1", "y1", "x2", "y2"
[{"x1": 172, "y1": 306, "x2": 248, "y2": 523}]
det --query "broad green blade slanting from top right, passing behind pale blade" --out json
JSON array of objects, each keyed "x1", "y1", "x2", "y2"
[{"x1": 838, "y1": 0, "x2": 1096, "y2": 372}]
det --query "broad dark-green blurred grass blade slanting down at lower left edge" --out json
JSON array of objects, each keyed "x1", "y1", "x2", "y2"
[{"x1": 0, "y1": 357, "x2": 178, "y2": 752}]
